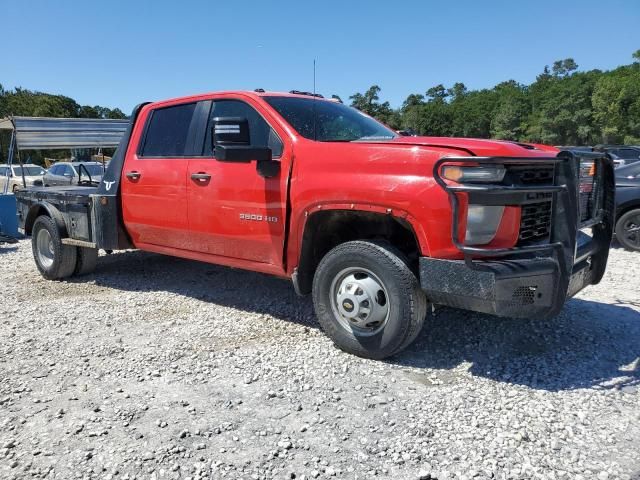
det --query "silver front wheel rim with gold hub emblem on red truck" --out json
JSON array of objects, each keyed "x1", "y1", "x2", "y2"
[{"x1": 330, "y1": 267, "x2": 389, "y2": 336}]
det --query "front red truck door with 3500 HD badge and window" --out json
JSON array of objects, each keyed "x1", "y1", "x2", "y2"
[{"x1": 187, "y1": 97, "x2": 290, "y2": 266}]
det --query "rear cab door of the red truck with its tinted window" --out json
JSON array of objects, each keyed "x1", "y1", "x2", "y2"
[{"x1": 120, "y1": 102, "x2": 196, "y2": 250}]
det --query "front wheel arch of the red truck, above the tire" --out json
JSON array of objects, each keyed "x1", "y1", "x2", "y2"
[{"x1": 292, "y1": 205, "x2": 426, "y2": 295}]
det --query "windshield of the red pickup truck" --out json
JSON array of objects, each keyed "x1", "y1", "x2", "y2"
[{"x1": 263, "y1": 97, "x2": 397, "y2": 142}]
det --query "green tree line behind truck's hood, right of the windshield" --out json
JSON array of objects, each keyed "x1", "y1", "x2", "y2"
[{"x1": 349, "y1": 50, "x2": 640, "y2": 145}]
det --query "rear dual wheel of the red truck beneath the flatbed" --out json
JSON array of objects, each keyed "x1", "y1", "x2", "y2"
[{"x1": 31, "y1": 215, "x2": 77, "y2": 280}]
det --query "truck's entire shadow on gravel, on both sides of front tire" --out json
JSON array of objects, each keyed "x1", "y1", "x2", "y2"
[{"x1": 87, "y1": 251, "x2": 640, "y2": 391}]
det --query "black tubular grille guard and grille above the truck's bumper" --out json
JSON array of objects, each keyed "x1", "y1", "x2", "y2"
[{"x1": 433, "y1": 151, "x2": 614, "y2": 275}]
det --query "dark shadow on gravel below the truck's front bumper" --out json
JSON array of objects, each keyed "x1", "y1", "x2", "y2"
[{"x1": 392, "y1": 299, "x2": 640, "y2": 391}]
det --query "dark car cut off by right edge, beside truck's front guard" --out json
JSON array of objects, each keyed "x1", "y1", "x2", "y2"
[{"x1": 615, "y1": 162, "x2": 640, "y2": 251}]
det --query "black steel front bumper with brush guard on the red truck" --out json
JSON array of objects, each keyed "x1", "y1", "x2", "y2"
[{"x1": 420, "y1": 151, "x2": 615, "y2": 318}]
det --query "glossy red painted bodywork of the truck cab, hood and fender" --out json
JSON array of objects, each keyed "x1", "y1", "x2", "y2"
[{"x1": 121, "y1": 92, "x2": 557, "y2": 276}]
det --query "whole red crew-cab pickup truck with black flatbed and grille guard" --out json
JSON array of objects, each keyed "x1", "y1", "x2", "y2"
[{"x1": 17, "y1": 90, "x2": 614, "y2": 358}]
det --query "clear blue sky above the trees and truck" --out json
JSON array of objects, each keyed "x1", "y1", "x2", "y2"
[{"x1": 0, "y1": 0, "x2": 640, "y2": 113}]
